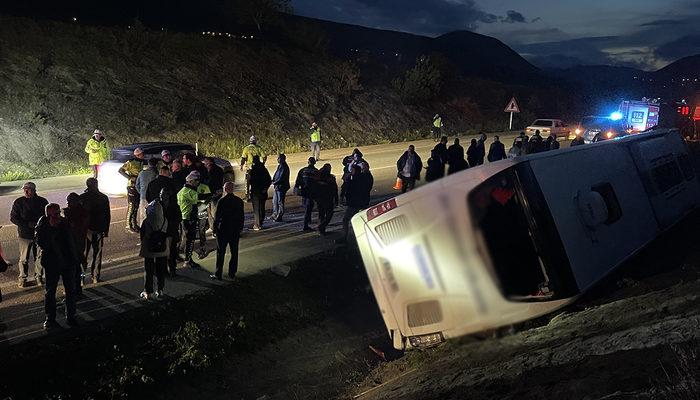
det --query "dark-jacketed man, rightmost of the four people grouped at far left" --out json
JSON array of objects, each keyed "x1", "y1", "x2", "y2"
[{"x1": 79, "y1": 178, "x2": 112, "y2": 283}]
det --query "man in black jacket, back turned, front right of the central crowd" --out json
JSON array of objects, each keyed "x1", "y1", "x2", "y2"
[{"x1": 209, "y1": 182, "x2": 244, "y2": 280}]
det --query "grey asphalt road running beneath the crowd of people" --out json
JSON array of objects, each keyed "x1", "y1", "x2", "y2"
[{"x1": 0, "y1": 134, "x2": 515, "y2": 345}]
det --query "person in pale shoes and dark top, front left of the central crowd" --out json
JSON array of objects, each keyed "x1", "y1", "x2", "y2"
[{"x1": 139, "y1": 199, "x2": 170, "y2": 300}]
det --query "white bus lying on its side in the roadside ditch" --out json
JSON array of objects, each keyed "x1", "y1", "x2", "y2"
[{"x1": 352, "y1": 130, "x2": 700, "y2": 349}]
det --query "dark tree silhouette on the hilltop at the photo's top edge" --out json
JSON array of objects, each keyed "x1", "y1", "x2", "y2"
[{"x1": 224, "y1": 0, "x2": 292, "y2": 32}]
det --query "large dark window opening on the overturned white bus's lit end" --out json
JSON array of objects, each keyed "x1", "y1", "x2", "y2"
[{"x1": 468, "y1": 163, "x2": 575, "y2": 301}]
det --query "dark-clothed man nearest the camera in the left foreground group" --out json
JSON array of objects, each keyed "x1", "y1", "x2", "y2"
[{"x1": 36, "y1": 203, "x2": 80, "y2": 329}]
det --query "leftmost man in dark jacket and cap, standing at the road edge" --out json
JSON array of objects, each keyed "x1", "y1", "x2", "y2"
[{"x1": 10, "y1": 182, "x2": 48, "y2": 288}]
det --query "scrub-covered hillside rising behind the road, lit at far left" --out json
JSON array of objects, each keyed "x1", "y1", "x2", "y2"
[{"x1": 0, "y1": 16, "x2": 556, "y2": 180}]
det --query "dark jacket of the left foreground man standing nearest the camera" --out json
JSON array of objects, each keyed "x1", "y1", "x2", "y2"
[{"x1": 36, "y1": 217, "x2": 80, "y2": 271}]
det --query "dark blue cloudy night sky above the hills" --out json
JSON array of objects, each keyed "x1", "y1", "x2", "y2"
[{"x1": 292, "y1": 0, "x2": 700, "y2": 70}]
